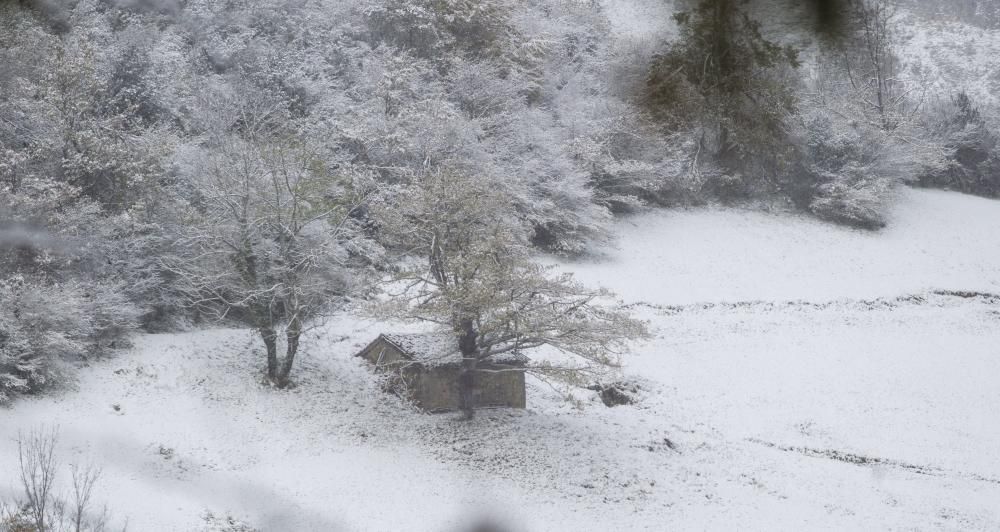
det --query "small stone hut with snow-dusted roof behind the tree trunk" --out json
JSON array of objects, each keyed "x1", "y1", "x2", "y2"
[{"x1": 357, "y1": 333, "x2": 528, "y2": 412}]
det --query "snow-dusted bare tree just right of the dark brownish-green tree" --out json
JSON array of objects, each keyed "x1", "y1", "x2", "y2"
[{"x1": 799, "y1": 0, "x2": 947, "y2": 208}]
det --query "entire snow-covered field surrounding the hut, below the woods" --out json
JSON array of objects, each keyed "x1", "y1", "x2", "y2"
[{"x1": 0, "y1": 191, "x2": 1000, "y2": 531}]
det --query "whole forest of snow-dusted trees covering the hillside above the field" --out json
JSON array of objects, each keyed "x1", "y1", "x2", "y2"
[{"x1": 0, "y1": 0, "x2": 1000, "y2": 404}]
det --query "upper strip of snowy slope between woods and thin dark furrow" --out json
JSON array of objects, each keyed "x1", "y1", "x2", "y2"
[{"x1": 573, "y1": 190, "x2": 1000, "y2": 305}]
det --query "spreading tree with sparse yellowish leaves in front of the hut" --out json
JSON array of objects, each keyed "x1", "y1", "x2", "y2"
[{"x1": 379, "y1": 171, "x2": 646, "y2": 417}]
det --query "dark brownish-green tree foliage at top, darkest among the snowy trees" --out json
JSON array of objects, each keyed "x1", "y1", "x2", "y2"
[{"x1": 645, "y1": 0, "x2": 799, "y2": 185}]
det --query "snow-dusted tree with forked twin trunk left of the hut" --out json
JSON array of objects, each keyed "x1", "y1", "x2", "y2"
[{"x1": 165, "y1": 132, "x2": 366, "y2": 388}]
